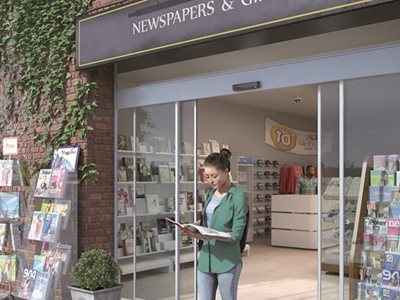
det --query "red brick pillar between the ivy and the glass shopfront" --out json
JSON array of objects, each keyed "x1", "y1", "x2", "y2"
[{"x1": 78, "y1": 66, "x2": 114, "y2": 253}]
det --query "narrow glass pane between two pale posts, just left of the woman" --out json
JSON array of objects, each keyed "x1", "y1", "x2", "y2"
[{"x1": 179, "y1": 101, "x2": 196, "y2": 299}]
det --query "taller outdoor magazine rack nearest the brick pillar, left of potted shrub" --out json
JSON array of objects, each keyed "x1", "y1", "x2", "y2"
[{"x1": 16, "y1": 145, "x2": 79, "y2": 300}]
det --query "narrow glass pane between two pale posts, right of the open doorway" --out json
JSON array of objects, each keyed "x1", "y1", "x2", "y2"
[{"x1": 319, "y1": 83, "x2": 339, "y2": 300}]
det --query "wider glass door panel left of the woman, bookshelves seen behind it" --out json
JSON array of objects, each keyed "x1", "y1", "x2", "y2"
[{"x1": 133, "y1": 103, "x2": 176, "y2": 300}]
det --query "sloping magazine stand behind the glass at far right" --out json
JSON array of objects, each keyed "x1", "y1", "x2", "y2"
[{"x1": 349, "y1": 155, "x2": 400, "y2": 300}]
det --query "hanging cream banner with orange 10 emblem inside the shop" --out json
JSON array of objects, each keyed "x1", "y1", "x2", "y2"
[{"x1": 265, "y1": 118, "x2": 318, "y2": 155}]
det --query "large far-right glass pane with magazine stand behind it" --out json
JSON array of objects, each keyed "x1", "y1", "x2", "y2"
[{"x1": 344, "y1": 74, "x2": 400, "y2": 300}]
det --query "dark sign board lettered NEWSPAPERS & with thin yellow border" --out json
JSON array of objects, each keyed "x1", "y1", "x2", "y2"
[{"x1": 76, "y1": 0, "x2": 388, "y2": 68}]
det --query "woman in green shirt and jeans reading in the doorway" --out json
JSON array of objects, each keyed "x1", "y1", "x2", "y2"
[{"x1": 187, "y1": 149, "x2": 248, "y2": 300}]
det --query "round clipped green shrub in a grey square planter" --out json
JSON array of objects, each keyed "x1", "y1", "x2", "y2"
[{"x1": 69, "y1": 249, "x2": 122, "y2": 300}]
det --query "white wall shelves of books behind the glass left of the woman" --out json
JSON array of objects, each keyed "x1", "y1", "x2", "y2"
[{"x1": 116, "y1": 150, "x2": 197, "y2": 275}]
